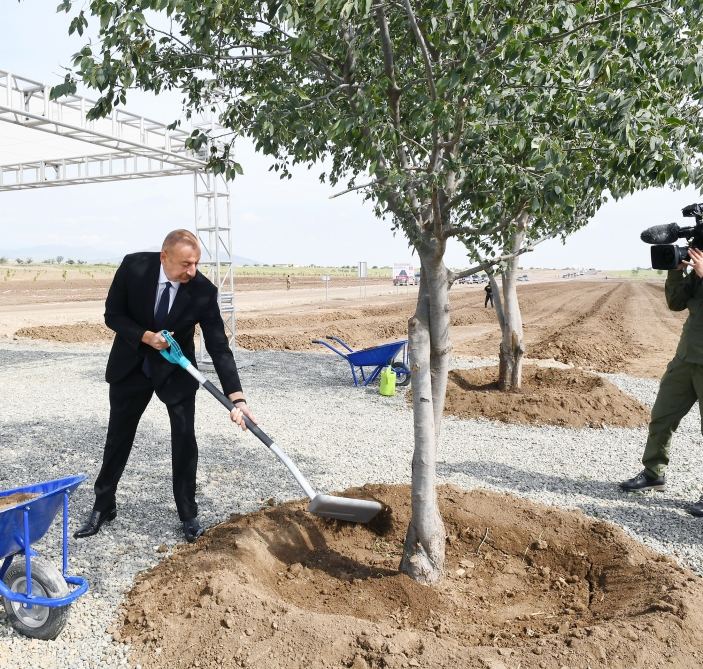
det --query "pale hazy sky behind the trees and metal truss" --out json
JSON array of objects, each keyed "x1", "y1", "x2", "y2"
[{"x1": 0, "y1": 0, "x2": 703, "y2": 269}]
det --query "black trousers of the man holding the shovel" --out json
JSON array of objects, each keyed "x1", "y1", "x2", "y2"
[{"x1": 94, "y1": 369, "x2": 198, "y2": 520}]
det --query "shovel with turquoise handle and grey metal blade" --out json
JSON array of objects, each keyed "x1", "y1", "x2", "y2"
[{"x1": 161, "y1": 330, "x2": 383, "y2": 523}]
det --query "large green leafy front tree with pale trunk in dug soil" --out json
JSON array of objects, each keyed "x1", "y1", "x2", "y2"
[{"x1": 57, "y1": 0, "x2": 703, "y2": 583}]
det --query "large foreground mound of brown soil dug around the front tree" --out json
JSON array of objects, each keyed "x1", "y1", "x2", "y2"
[{"x1": 118, "y1": 486, "x2": 703, "y2": 669}]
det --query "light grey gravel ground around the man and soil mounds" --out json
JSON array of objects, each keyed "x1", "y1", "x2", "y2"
[{"x1": 0, "y1": 342, "x2": 703, "y2": 669}]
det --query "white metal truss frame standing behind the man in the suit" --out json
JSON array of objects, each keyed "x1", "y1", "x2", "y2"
[{"x1": 0, "y1": 70, "x2": 235, "y2": 354}]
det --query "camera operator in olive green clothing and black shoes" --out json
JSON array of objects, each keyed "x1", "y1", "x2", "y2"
[{"x1": 620, "y1": 248, "x2": 703, "y2": 516}]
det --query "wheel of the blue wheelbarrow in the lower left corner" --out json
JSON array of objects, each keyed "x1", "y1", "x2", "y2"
[{"x1": 3, "y1": 559, "x2": 70, "y2": 641}]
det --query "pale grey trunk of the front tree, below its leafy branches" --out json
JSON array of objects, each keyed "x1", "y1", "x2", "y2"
[{"x1": 400, "y1": 254, "x2": 451, "y2": 585}]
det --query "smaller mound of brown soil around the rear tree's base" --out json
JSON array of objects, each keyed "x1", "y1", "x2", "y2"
[{"x1": 444, "y1": 365, "x2": 649, "y2": 428}]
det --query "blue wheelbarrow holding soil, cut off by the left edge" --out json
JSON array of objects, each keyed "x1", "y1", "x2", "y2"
[{"x1": 0, "y1": 474, "x2": 88, "y2": 640}]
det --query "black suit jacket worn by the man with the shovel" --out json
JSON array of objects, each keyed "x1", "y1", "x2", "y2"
[{"x1": 105, "y1": 252, "x2": 242, "y2": 404}]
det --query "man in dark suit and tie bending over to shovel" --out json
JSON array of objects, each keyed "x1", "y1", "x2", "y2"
[{"x1": 74, "y1": 230, "x2": 254, "y2": 542}]
